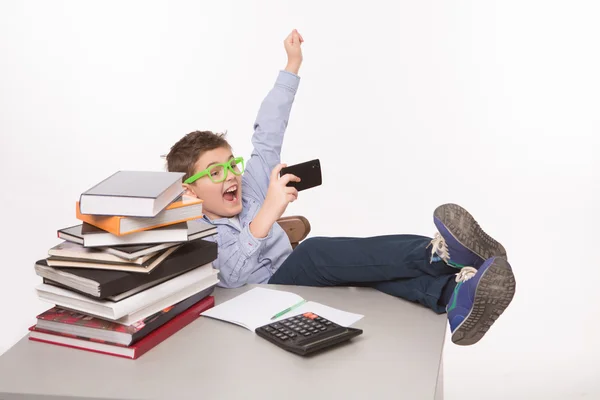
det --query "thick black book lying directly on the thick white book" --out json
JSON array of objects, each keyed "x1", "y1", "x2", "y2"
[{"x1": 35, "y1": 239, "x2": 218, "y2": 299}]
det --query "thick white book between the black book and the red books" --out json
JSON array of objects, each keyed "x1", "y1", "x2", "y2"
[{"x1": 36, "y1": 265, "x2": 219, "y2": 325}]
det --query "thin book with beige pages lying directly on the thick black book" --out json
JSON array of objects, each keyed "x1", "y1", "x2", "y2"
[{"x1": 46, "y1": 247, "x2": 178, "y2": 274}]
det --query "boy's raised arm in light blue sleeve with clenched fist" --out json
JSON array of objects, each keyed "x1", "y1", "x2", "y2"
[{"x1": 243, "y1": 30, "x2": 304, "y2": 201}]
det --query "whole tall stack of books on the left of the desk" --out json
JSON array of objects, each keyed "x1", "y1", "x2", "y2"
[{"x1": 29, "y1": 171, "x2": 219, "y2": 359}]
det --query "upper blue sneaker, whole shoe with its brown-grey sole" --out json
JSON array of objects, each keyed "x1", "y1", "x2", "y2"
[{"x1": 431, "y1": 204, "x2": 507, "y2": 268}]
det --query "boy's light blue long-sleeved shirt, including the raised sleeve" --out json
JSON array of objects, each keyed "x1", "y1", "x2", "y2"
[{"x1": 204, "y1": 71, "x2": 300, "y2": 288}]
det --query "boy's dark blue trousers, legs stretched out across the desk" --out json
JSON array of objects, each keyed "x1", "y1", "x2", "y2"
[{"x1": 269, "y1": 235, "x2": 458, "y2": 314}]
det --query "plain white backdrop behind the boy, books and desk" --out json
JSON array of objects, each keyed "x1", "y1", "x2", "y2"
[{"x1": 0, "y1": 0, "x2": 600, "y2": 400}]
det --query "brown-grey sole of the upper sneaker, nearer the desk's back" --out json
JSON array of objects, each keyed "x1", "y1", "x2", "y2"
[{"x1": 433, "y1": 204, "x2": 508, "y2": 260}]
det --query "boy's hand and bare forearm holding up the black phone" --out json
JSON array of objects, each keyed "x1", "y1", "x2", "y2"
[{"x1": 250, "y1": 164, "x2": 300, "y2": 238}]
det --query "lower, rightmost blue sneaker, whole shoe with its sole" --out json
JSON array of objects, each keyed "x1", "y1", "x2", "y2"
[{"x1": 446, "y1": 257, "x2": 516, "y2": 346}]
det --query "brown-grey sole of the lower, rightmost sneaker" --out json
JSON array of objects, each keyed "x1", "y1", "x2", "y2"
[{"x1": 452, "y1": 258, "x2": 516, "y2": 346}]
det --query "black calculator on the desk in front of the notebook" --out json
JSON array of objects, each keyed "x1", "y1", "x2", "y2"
[{"x1": 255, "y1": 312, "x2": 363, "y2": 356}]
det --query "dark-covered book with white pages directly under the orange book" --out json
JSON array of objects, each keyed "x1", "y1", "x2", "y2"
[{"x1": 57, "y1": 219, "x2": 217, "y2": 247}]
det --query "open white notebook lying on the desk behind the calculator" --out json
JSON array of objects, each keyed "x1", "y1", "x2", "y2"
[{"x1": 201, "y1": 288, "x2": 363, "y2": 332}]
